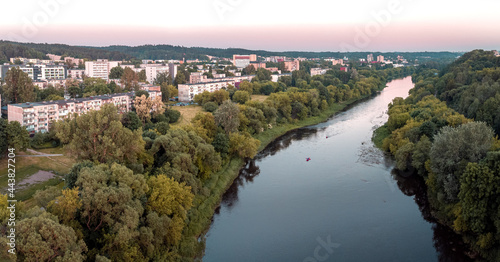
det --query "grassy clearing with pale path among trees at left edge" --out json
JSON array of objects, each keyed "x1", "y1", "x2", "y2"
[{"x1": 0, "y1": 147, "x2": 76, "y2": 200}]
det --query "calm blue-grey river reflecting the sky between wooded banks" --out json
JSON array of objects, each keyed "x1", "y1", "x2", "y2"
[{"x1": 203, "y1": 77, "x2": 469, "y2": 262}]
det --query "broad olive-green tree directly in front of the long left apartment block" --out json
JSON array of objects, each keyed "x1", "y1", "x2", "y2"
[{"x1": 55, "y1": 104, "x2": 144, "y2": 163}]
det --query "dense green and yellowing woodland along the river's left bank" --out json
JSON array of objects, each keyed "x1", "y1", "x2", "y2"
[{"x1": 0, "y1": 63, "x2": 414, "y2": 261}]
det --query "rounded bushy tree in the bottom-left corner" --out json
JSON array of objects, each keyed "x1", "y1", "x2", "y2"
[{"x1": 16, "y1": 214, "x2": 87, "y2": 261}]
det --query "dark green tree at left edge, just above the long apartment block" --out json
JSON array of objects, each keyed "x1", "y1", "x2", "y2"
[{"x1": 3, "y1": 67, "x2": 35, "y2": 104}]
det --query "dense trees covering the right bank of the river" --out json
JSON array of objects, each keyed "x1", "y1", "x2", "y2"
[{"x1": 376, "y1": 50, "x2": 500, "y2": 261}]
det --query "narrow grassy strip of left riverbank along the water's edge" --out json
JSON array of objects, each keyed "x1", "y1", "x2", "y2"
[{"x1": 180, "y1": 86, "x2": 385, "y2": 261}]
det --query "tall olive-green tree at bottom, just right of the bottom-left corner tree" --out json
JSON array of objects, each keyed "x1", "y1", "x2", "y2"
[{"x1": 76, "y1": 163, "x2": 149, "y2": 261}]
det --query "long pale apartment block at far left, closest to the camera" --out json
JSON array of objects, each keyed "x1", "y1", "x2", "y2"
[{"x1": 8, "y1": 90, "x2": 146, "y2": 134}]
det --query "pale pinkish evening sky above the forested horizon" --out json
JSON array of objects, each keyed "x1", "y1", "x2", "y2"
[{"x1": 0, "y1": 0, "x2": 500, "y2": 52}]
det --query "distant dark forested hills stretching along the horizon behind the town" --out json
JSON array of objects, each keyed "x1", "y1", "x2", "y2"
[{"x1": 0, "y1": 40, "x2": 462, "y2": 63}]
